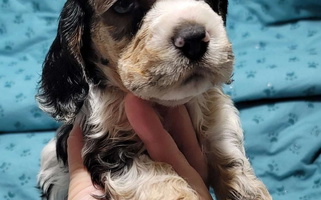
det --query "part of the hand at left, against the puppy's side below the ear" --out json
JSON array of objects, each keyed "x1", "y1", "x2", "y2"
[{"x1": 67, "y1": 125, "x2": 104, "y2": 200}]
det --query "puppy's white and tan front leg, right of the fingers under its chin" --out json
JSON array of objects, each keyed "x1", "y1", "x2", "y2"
[{"x1": 190, "y1": 89, "x2": 272, "y2": 200}]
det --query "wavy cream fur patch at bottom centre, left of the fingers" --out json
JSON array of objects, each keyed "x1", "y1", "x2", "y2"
[{"x1": 105, "y1": 155, "x2": 199, "y2": 200}]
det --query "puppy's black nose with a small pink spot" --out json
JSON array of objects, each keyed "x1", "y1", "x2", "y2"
[{"x1": 173, "y1": 24, "x2": 210, "y2": 60}]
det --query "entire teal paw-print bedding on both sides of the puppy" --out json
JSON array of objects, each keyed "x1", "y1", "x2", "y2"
[{"x1": 0, "y1": 0, "x2": 321, "y2": 200}]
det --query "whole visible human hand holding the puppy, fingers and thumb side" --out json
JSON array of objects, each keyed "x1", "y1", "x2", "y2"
[{"x1": 67, "y1": 94, "x2": 211, "y2": 200}]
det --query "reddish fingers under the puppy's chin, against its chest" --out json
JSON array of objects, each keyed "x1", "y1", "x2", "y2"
[{"x1": 125, "y1": 94, "x2": 212, "y2": 200}]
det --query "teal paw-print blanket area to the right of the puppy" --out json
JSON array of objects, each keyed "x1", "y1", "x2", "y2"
[{"x1": 225, "y1": 0, "x2": 321, "y2": 200}]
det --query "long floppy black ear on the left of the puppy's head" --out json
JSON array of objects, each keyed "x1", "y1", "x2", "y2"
[{"x1": 37, "y1": 0, "x2": 89, "y2": 121}]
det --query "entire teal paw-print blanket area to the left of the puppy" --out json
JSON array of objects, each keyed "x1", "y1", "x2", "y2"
[{"x1": 0, "y1": 0, "x2": 65, "y2": 200}]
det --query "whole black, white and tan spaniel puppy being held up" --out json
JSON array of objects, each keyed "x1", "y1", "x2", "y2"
[{"x1": 37, "y1": 0, "x2": 271, "y2": 200}]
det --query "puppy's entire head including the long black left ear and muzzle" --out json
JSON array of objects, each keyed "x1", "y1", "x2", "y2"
[{"x1": 37, "y1": 0, "x2": 233, "y2": 121}]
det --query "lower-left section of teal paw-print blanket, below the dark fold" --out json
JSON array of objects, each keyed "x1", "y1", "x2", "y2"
[{"x1": 0, "y1": 132, "x2": 54, "y2": 200}]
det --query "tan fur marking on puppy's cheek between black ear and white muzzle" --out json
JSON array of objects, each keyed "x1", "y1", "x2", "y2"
[{"x1": 90, "y1": 0, "x2": 158, "y2": 90}]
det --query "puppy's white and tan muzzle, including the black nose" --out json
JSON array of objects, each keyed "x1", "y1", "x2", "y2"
[{"x1": 117, "y1": 0, "x2": 233, "y2": 106}]
